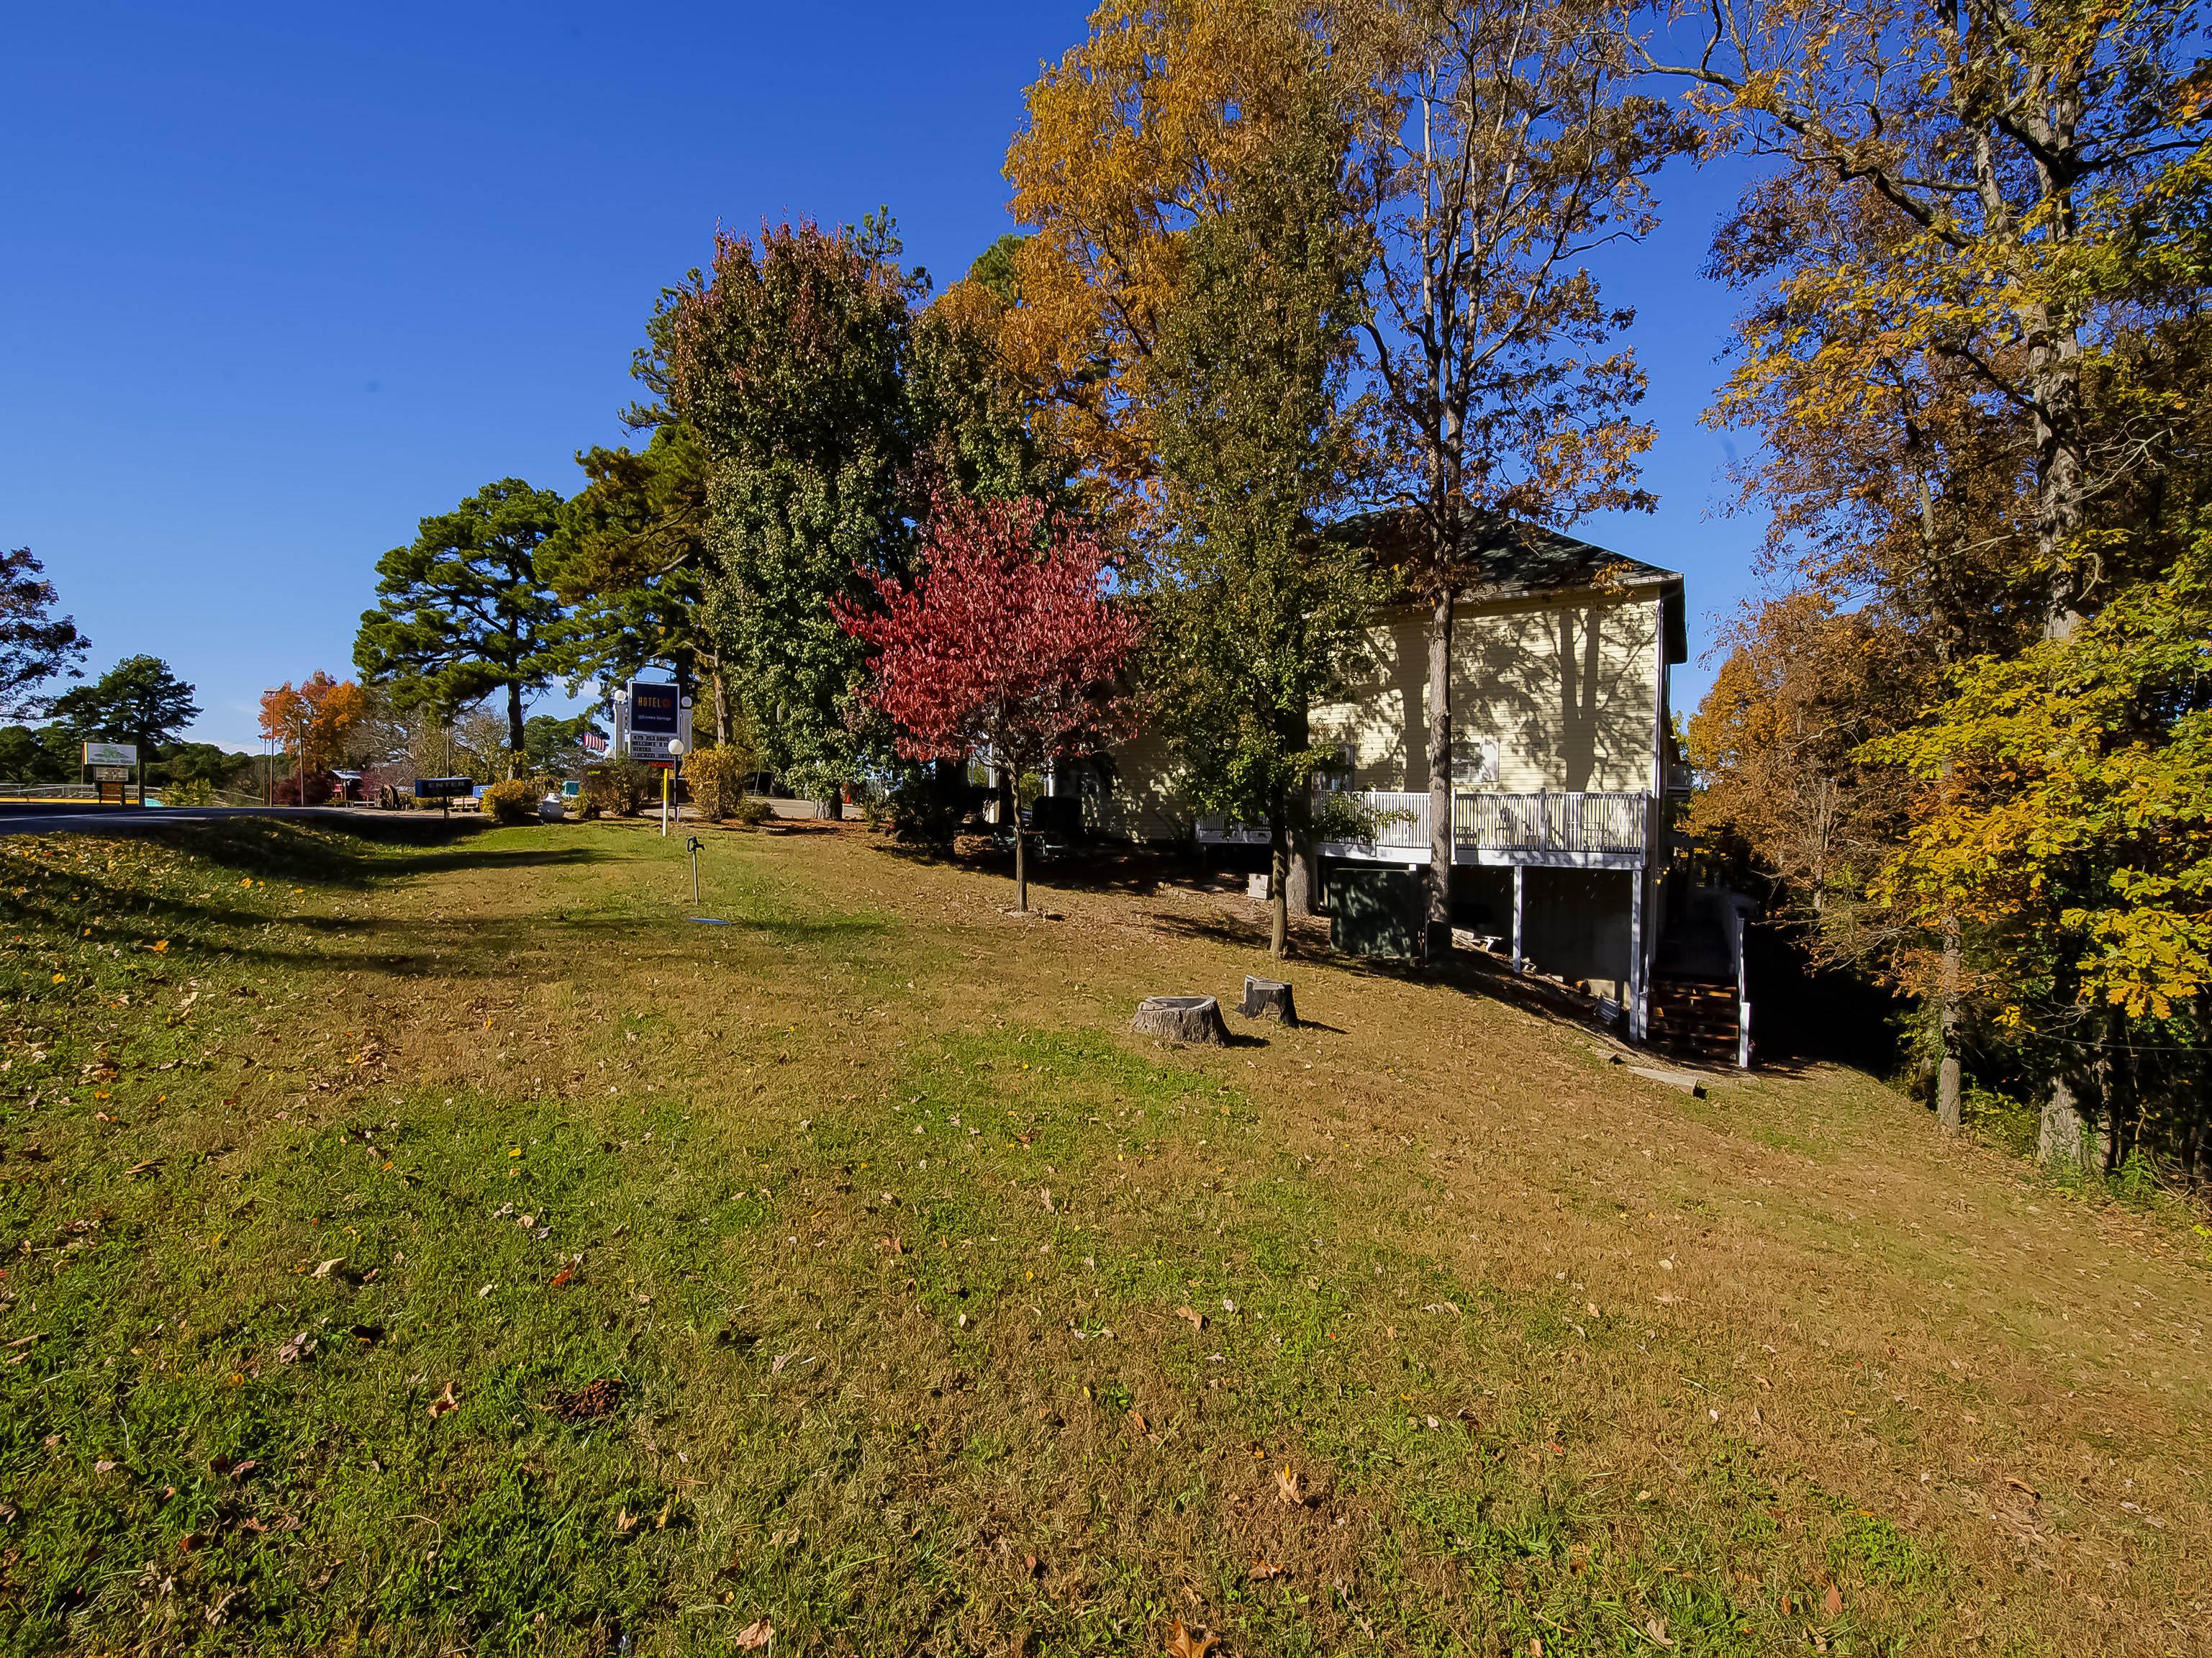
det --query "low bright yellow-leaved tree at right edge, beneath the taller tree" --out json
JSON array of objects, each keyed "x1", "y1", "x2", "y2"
[{"x1": 1874, "y1": 533, "x2": 2212, "y2": 1176}]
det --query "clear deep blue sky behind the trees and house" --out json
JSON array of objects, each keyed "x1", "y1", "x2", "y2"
[{"x1": 0, "y1": 0, "x2": 1759, "y2": 747}]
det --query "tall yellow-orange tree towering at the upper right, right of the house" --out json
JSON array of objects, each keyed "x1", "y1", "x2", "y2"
[{"x1": 1664, "y1": 0, "x2": 2206, "y2": 1138}]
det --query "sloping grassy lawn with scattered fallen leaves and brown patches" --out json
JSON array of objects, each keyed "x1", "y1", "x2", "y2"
[{"x1": 0, "y1": 825, "x2": 2212, "y2": 1658}]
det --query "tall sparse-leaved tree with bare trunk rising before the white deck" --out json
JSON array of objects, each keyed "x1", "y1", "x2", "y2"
[{"x1": 1358, "y1": 0, "x2": 1692, "y2": 951}]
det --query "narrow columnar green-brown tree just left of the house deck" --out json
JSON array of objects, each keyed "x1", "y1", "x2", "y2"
[{"x1": 1141, "y1": 37, "x2": 1384, "y2": 957}]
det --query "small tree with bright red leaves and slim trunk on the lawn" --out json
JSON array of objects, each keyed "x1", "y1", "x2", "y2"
[{"x1": 834, "y1": 499, "x2": 1137, "y2": 911}]
